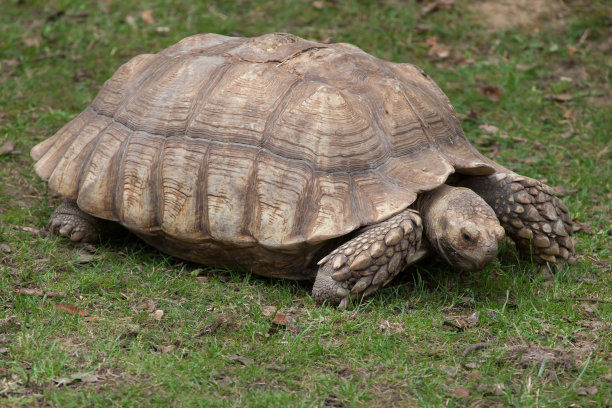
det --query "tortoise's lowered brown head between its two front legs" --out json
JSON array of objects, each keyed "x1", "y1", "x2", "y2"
[{"x1": 413, "y1": 184, "x2": 504, "y2": 270}]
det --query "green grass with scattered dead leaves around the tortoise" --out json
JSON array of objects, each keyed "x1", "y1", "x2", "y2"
[{"x1": 0, "y1": 0, "x2": 612, "y2": 407}]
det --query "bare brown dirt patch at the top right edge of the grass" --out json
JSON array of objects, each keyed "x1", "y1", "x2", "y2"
[{"x1": 469, "y1": 0, "x2": 564, "y2": 31}]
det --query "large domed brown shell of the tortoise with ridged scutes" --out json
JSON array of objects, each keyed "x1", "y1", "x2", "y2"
[{"x1": 31, "y1": 33, "x2": 494, "y2": 274}]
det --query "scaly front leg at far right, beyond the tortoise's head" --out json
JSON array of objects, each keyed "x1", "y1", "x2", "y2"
[{"x1": 460, "y1": 173, "x2": 574, "y2": 263}]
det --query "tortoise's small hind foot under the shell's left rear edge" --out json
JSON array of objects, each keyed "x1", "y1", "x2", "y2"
[{"x1": 49, "y1": 198, "x2": 110, "y2": 242}]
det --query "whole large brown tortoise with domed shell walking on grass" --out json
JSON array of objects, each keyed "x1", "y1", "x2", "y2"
[{"x1": 31, "y1": 33, "x2": 573, "y2": 307}]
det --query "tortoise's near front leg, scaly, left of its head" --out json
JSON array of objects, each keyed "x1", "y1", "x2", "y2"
[{"x1": 312, "y1": 209, "x2": 423, "y2": 308}]
